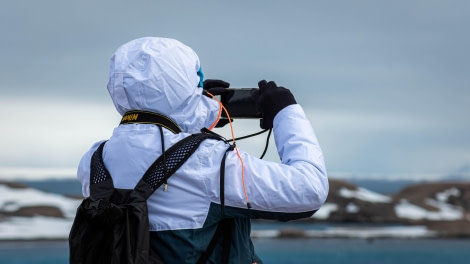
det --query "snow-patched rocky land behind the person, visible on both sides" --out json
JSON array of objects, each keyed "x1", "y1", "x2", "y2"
[{"x1": 0, "y1": 179, "x2": 470, "y2": 240}]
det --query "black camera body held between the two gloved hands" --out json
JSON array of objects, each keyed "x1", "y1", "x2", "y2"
[{"x1": 220, "y1": 88, "x2": 261, "y2": 119}]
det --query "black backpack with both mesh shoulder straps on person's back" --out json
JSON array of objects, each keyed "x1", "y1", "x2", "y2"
[{"x1": 69, "y1": 133, "x2": 216, "y2": 264}]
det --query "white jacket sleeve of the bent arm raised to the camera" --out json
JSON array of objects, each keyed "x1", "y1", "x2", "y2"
[{"x1": 219, "y1": 104, "x2": 328, "y2": 213}]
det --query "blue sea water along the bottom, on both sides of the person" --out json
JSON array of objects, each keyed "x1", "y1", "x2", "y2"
[{"x1": 0, "y1": 238, "x2": 470, "y2": 264}]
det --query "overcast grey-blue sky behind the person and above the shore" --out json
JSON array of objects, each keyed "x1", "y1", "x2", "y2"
[{"x1": 0, "y1": 0, "x2": 470, "y2": 179}]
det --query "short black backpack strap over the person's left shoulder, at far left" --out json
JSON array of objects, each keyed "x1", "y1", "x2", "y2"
[{"x1": 90, "y1": 141, "x2": 114, "y2": 200}]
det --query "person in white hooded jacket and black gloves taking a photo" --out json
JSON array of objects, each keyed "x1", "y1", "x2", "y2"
[{"x1": 77, "y1": 37, "x2": 328, "y2": 264}]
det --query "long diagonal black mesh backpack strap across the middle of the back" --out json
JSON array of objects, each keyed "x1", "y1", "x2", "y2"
[{"x1": 134, "y1": 133, "x2": 220, "y2": 199}]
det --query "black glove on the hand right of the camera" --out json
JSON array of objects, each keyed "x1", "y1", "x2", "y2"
[{"x1": 254, "y1": 80, "x2": 297, "y2": 129}]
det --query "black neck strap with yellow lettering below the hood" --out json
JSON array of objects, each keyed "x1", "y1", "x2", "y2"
[{"x1": 120, "y1": 110, "x2": 181, "y2": 134}]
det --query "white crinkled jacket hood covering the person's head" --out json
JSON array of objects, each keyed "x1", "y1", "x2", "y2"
[{"x1": 108, "y1": 37, "x2": 220, "y2": 133}]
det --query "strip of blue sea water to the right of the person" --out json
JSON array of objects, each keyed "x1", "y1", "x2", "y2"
[{"x1": 255, "y1": 238, "x2": 470, "y2": 264}]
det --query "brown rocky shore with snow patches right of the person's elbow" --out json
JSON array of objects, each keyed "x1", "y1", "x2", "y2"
[{"x1": 304, "y1": 180, "x2": 470, "y2": 238}]
